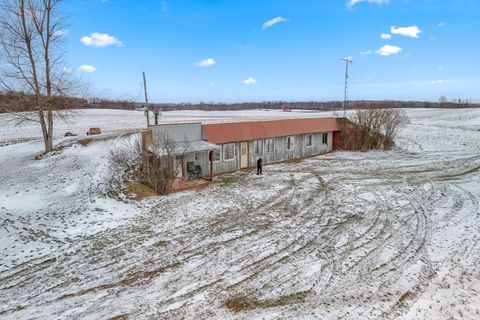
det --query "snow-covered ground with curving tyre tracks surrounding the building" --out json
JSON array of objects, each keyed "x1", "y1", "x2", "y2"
[{"x1": 0, "y1": 109, "x2": 480, "y2": 319}]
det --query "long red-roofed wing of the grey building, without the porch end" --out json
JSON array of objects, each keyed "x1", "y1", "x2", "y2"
[{"x1": 202, "y1": 117, "x2": 340, "y2": 173}]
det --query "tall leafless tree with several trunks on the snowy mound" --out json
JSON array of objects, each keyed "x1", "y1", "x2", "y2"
[{"x1": 0, "y1": 0, "x2": 77, "y2": 152}]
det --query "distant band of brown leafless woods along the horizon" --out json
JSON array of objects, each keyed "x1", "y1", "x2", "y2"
[{"x1": 0, "y1": 92, "x2": 480, "y2": 113}]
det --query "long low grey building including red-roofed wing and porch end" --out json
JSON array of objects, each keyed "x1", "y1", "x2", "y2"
[{"x1": 144, "y1": 117, "x2": 340, "y2": 186}]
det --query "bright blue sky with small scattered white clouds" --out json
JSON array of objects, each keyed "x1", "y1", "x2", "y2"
[{"x1": 61, "y1": 0, "x2": 480, "y2": 102}]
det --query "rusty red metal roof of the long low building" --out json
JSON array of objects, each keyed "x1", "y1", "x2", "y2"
[{"x1": 202, "y1": 117, "x2": 340, "y2": 144}]
